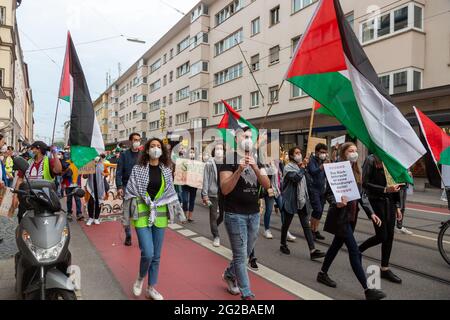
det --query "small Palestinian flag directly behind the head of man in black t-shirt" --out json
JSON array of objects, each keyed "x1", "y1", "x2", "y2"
[{"x1": 218, "y1": 100, "x2": 258, "y2": 147}]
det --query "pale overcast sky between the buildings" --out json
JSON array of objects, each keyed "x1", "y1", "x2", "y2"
[{"x1": 17, "y1": 0, "x2": 198, "y2": 140}]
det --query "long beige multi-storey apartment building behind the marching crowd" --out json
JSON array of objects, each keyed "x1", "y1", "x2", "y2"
[{"x1": 97, "y1": 0, "x2": 450, "y2": 155}]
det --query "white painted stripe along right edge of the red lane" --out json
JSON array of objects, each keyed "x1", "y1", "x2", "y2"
[{"x1": 191, "y1": 237, "x2": 332, "y2": 300}]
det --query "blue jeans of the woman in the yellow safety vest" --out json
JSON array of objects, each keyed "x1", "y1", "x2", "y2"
[{"x1": 136, "y1": 226, "x2": 165, "y2": 286}]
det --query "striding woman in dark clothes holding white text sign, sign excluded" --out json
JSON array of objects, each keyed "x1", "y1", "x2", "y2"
[{"x1": 317, "y1": 142, "x2": 386, "y2": 300}]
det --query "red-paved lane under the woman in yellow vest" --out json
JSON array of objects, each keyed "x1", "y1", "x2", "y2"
[{"x1": 82, "y1": 222, "x2": 299, "y2": 300}]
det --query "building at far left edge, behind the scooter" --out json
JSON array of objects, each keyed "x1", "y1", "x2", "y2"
[{"x1": 0, "y1": 0, "x2": 34, "y2": 148}]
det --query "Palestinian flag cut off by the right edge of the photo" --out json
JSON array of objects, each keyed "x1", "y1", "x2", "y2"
[{"x1": 414, "y1": 107, "x2": 450, "y2": 165}]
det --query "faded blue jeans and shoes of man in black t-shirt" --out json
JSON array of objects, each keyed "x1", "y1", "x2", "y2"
[{"x1": 225, "y1": 212, "x2": 259, "y2": 298}]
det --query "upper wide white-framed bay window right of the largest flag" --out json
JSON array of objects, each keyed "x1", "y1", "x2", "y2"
[{"x1": 360, "y1": 3, "x2": 423, "y2": 43}]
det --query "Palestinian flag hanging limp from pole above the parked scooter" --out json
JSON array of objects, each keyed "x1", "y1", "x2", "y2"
[{"x1": 59, "y1": 32, "x2": 105, "y2": 168}]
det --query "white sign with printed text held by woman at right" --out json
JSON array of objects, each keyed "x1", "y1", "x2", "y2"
[{"x1": 323, "y1": 161, "x2": 361, "y2": 202}]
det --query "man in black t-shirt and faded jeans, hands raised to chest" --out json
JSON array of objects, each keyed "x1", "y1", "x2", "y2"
[{"x1": 219, "y1": 128, "x2": 270, "y2": 300}]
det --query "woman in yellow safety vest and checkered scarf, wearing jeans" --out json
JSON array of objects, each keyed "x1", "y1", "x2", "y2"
[{"x1": 124, "y1": 138, "x2": 182, "y2": 300}]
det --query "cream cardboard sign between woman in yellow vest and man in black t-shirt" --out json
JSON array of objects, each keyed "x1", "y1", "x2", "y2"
[{"x1": 174, "y1": 158, "x2": 205, "y2": 189}]
